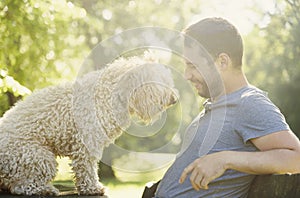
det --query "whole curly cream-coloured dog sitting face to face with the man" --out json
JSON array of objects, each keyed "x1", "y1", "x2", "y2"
[{"x1": 0, "y1": 53, "x2": 177, "y2": 195}]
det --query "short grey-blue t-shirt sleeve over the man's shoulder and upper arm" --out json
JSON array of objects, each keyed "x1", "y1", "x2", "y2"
[{"x1": 235, "y1": 93, "x2": 290, "y2": 143}]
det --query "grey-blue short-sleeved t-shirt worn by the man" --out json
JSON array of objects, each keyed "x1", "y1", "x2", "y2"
[{"x1": 155, "y1": 86, "x2": 289, "y2": 198}]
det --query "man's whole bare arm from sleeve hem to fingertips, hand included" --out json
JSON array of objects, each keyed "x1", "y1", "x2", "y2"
[{"x1": 179, "y1": 131, "x2": 300, "y2": 190}]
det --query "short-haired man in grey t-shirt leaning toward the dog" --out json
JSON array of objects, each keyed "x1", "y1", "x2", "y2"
[{"x1": 155, "y1": 18, "x2": 300, "y2": 198}]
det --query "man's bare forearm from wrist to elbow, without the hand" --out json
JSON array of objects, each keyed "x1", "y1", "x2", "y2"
[{"x1": 223, "y1": 149, "x2": 300, "y2": 174}]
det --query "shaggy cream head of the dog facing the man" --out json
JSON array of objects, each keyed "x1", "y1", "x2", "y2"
[{"x1": 124, "y1": 63, "x2": 178, "y2": 123}]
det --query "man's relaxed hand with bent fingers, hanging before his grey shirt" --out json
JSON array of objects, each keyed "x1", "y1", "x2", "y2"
[{"x1": 179, "y1": 152, "x2": 227, "y2": 190}]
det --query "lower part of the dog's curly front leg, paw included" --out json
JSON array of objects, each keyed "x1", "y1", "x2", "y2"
[{"x1": 72, "y1": 154, "x2": 105, "y2": 195}]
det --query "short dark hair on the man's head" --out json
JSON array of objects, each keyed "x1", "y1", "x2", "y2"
[{"x1": 183, "y1": 17, "x2": 243, "y2": 67}]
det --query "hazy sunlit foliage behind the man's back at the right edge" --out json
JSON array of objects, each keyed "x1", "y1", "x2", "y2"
[{"x1": 246, "y1": 0, "x2": 300, "y2": 136}]
